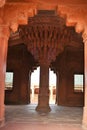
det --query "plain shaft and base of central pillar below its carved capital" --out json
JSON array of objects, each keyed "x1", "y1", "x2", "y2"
[{"x1": 36, "y1": 64, "x2": 51, "y2": 112}]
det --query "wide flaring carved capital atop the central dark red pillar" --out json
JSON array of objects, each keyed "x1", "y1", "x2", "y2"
[{"x1": 19, "y1": 11, "x2": 83, "y2": 65}]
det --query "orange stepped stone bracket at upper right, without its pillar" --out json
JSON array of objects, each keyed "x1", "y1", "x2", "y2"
[{"x1": 58, "y1": 5, "x2": 87, "y2": 33}]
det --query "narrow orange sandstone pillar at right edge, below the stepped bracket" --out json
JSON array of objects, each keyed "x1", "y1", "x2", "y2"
[{"x1": 83, "y1": 33, "x2": 87, "y2": 127}]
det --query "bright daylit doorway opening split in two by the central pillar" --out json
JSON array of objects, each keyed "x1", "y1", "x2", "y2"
[{"x1": 30, "y1": 67, "x2": 56, "y2": 104}]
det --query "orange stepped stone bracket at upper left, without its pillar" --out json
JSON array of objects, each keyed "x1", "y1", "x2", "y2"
[{"x1": 0, "y1": 3, "x2": 36, "y2": 32}]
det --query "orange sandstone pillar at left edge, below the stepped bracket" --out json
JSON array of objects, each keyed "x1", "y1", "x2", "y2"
[{"x1": 0, "y1": 26, "x2": 9, "y2": 125}]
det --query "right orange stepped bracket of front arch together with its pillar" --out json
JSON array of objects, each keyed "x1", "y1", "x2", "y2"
[{"x1": 58, "y1": 5, "x2": 87, "y2": 127}]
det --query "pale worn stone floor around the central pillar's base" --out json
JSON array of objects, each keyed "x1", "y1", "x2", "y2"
[{"x1": 0, "y1": 105, "x2": 86, "y2": 130}]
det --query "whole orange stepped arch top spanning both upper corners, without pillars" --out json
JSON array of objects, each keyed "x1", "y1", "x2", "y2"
[{"x1": 0, "y1": 1, "x2": 87, "y2": 42}]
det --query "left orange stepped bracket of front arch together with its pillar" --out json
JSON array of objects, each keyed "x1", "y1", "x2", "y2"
[{"x1": 0, "y1": 3, "x2": 35, "y2": 125}]
